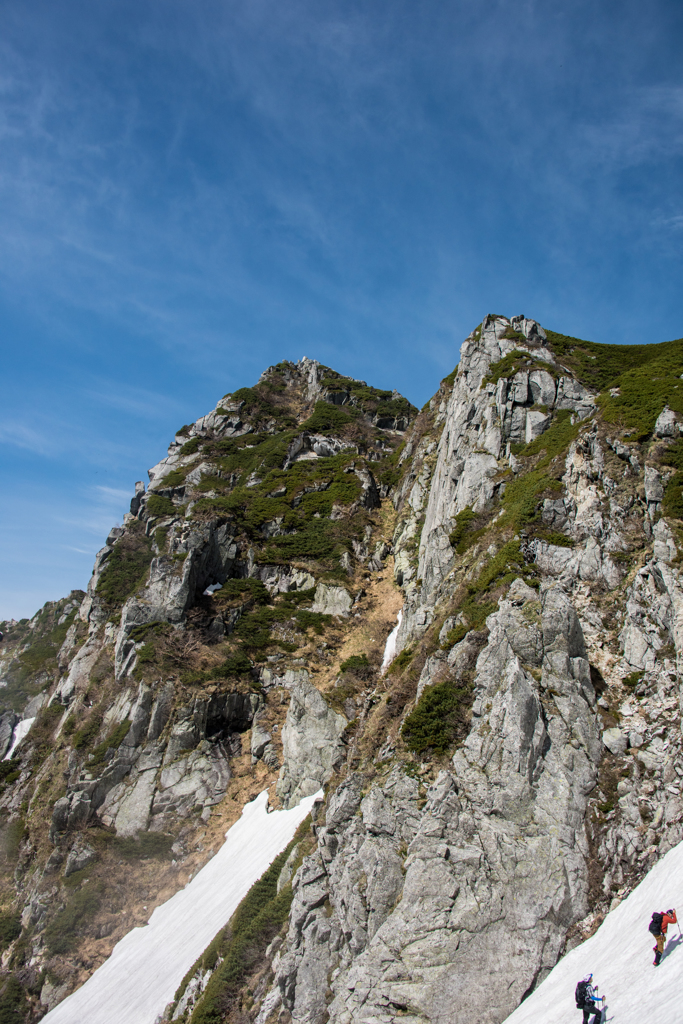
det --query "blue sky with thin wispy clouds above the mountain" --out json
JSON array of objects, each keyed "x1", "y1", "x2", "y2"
[{"x1": 0, "y1": 0, "x2": 683, "y2": 618}]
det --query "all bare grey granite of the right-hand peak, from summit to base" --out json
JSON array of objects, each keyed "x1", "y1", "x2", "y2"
[{"x1": 250, "y1": 317, "x2": 683, "y2": 1024}]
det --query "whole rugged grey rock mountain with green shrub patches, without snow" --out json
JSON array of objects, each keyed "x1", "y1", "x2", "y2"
[{"x1": 0, "y1": 316, "x2": 683, "y2": 1024}]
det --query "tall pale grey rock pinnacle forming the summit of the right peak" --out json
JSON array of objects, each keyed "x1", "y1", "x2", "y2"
[{"x1": 394, "y1": 316, "x2": 595, "y2": 643}]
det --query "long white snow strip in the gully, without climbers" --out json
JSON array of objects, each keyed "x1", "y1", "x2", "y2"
[{"x1": 43, "y1": 791, "x2": 321, "y2": 1024}]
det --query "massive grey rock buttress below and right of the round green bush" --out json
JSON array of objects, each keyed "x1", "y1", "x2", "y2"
[{"x1": 270, "y1": 581, "x2": 601, "y2": 1024}]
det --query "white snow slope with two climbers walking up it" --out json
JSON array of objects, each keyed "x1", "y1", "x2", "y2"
[{"x1": 505, "y1": 843, "x2": 683, "y2": 1024}]
